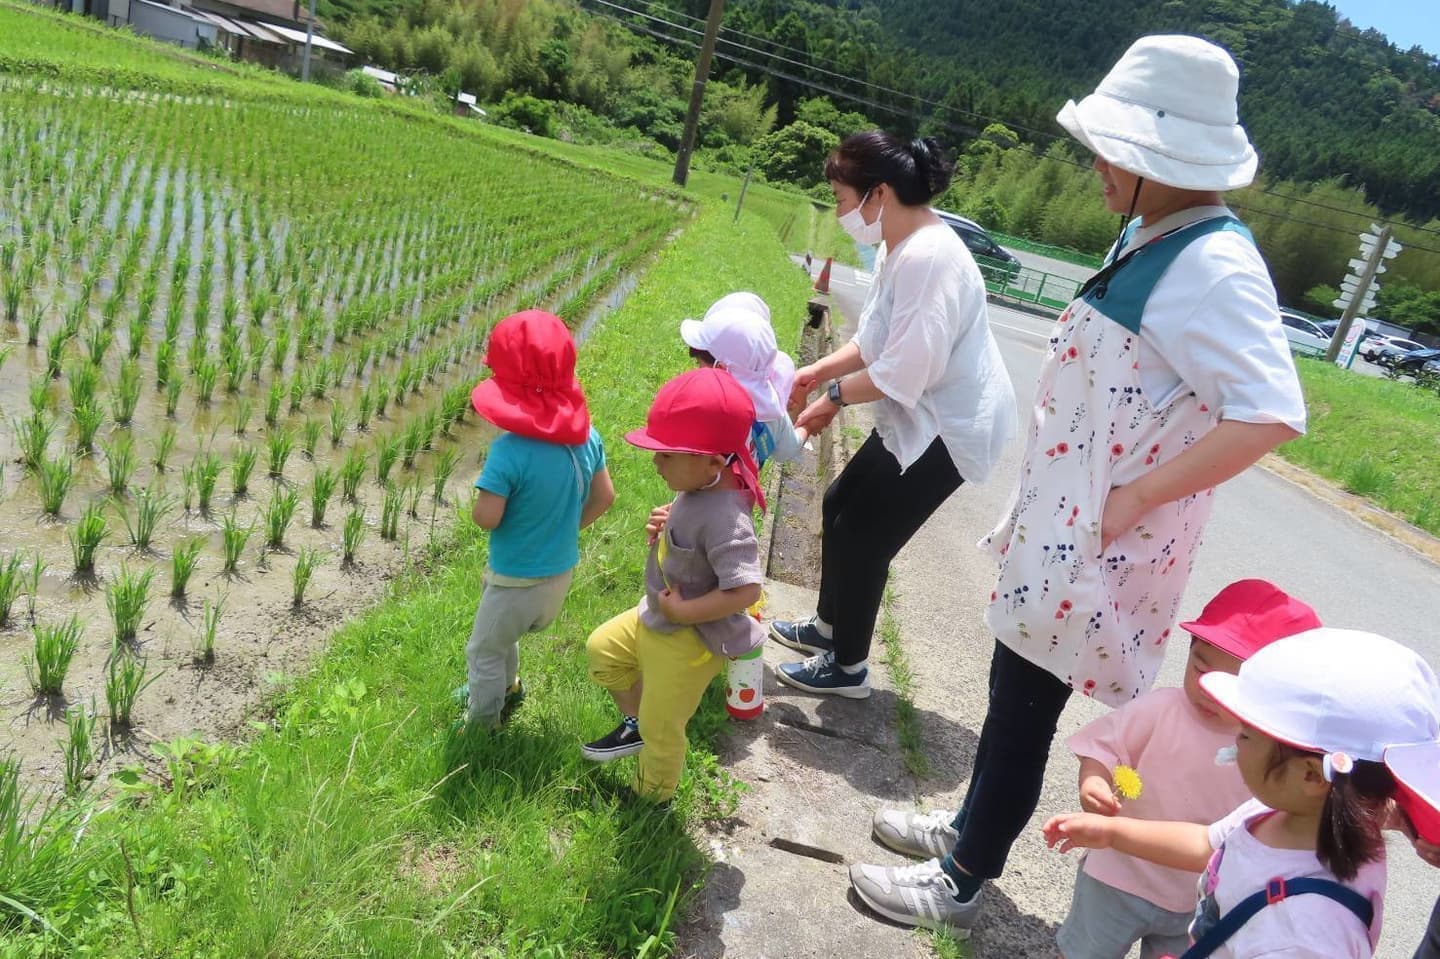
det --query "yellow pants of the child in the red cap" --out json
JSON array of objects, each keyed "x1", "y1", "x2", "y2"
[{"x1": 585, "y1": 609, "x2": 724, "y2": 802}]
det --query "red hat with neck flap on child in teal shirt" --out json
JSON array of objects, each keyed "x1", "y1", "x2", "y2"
[{"x1": 469, "y1": 310, "x2": 590, "y2": 446}]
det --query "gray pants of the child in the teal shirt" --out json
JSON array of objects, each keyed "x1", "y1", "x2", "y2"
[{"x1": 465, "y1": 569, "x2": 573, "y2": 726}]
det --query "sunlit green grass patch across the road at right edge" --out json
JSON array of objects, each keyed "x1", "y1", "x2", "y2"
[{"x1": 1279, "y1": 360, "x2": 1440, "y2": 534}]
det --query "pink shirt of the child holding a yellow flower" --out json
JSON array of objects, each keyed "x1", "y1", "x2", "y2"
[{"x1": 1066, "y1": 688, "x2": 1250, "y2": 913}]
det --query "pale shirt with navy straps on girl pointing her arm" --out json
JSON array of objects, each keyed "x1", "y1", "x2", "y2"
[{"x1": 1201, "y1": 799, "x2": 1385, "y2": 959}]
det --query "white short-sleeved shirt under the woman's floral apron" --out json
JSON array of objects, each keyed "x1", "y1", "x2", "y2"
[{"x1": 1120, "y1": 206, "x2": 1305, "y2": 433}]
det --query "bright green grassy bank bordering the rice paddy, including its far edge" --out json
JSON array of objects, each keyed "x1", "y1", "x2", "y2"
[{"x1": 0, "y1": 4, "x2": 812, "y2": 956}]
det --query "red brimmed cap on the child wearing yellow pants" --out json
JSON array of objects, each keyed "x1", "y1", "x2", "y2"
[{"x1": 625, "y1": 367, "x2": 765, "y2": 510}]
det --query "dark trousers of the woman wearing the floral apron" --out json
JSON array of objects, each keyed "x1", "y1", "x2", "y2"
[{"x1": 950, "y1": 642, "x2": 1070, "y2": 878}]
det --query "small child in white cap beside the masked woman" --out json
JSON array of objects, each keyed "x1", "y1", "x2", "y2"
[{"x1": 680, "y1": 292, "x2": 808, "y2": 467}]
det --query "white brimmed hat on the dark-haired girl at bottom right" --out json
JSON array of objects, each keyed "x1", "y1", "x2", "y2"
[{"x1": 1200, "y1": 626, "x2": 1440, "y2": 775}]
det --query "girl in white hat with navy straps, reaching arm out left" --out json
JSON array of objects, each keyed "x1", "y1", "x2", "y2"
[{"x1": 1044, "y1": 628, "x2": 1440, "y2": 959}]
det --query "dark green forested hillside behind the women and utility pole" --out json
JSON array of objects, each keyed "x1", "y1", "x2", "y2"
[{"x1": 321, "y1": 0, "x2": 1440, "y2": 330}]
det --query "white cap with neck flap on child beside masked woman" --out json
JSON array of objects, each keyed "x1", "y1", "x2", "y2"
[{"x1": 680, "y1": 292, "x2": 795, "y2": 423}]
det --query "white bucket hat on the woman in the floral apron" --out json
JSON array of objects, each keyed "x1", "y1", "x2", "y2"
[{"x1": 1057, "y1": 36, "x2": 1259, "y2": 190}]
